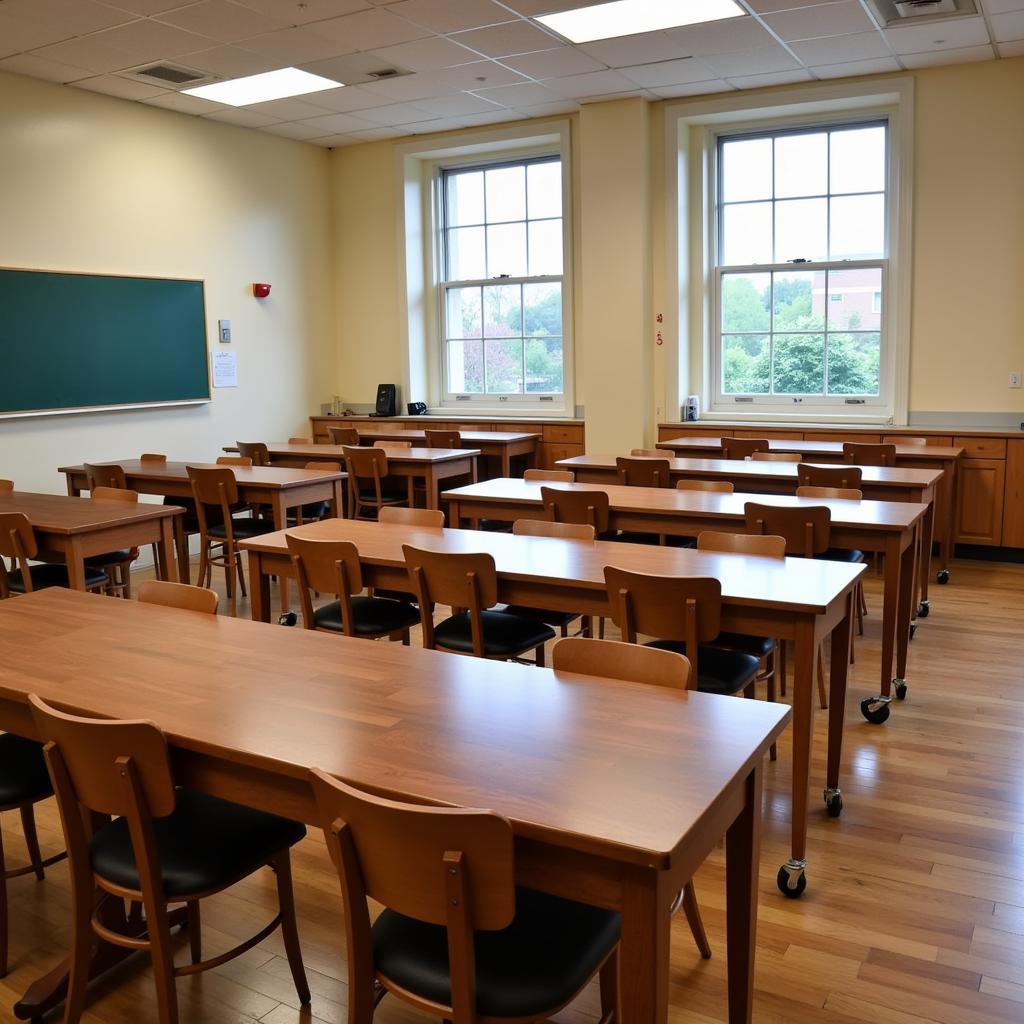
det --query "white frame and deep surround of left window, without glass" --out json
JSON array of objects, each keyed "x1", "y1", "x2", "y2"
[{"x1": 397, "y1": 120, "x2": 575, "y2": 419}]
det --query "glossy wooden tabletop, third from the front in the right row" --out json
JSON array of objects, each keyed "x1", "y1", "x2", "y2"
[{"x1": 442, "y1": 477, "x2": 928, "y2": 532}]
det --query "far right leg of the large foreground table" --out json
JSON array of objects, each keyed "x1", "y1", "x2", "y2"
[{"x1": 725, "y1": 762, "x2": 763, "y2": 1024}]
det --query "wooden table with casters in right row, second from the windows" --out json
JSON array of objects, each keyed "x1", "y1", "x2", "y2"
[{"x1": 556, "y1": 455, "x2": 942, "y2": 617}]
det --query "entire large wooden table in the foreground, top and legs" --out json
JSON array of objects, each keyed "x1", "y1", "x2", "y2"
[{"x1": 0, "y1": 589, "x2": 791, "y2": 1024}]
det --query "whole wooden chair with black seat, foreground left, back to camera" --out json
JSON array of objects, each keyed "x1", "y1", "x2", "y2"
[{"x1": 29, "y1": 695, "x2": 309, "y2": 1024}]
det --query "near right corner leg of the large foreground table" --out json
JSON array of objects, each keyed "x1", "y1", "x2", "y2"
[{"x1": 618, "y1": 865, "x2": 672, "y2": 1024}]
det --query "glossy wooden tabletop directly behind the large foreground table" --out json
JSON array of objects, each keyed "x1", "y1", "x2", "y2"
[{"x1": 240, "y1": 516, "x2": 863, "y2": 614}]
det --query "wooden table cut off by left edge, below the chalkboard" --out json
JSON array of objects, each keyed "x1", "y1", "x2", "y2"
[{"x1": 0, "y1": 490, "x2": 184, "y2": 590}]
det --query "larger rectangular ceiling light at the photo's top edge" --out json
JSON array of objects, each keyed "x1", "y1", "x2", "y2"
[{"x1": 535, "y1": 0, "x2": 745, "y2": 43}]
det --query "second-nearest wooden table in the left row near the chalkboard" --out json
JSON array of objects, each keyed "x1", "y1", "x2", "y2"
[{"x1": 57, "y1": 459, "x2": 346, "y2": 585}]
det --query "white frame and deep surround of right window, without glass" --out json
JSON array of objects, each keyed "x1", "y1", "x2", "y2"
[{"x1": 666, "y1": 78, "x2": 913, "y2": 424}]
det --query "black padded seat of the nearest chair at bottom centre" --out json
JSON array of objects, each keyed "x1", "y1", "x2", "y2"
[{"x1": 373, "y1": 888, "x2": 620, "y2": 1019}]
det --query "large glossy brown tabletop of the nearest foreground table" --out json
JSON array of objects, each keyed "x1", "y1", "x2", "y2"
[{"x1": 0, "y1": 589, "x2": 791, "y2": 866}]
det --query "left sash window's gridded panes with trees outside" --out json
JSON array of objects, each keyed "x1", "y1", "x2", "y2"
[{"x1": 439, "y1": 157, "x2": 565, "y2": 401}]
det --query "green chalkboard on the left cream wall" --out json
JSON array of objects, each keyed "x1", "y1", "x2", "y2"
[{"x1": 0, "y1": 269, "x2": 210, "y2": 416}]
